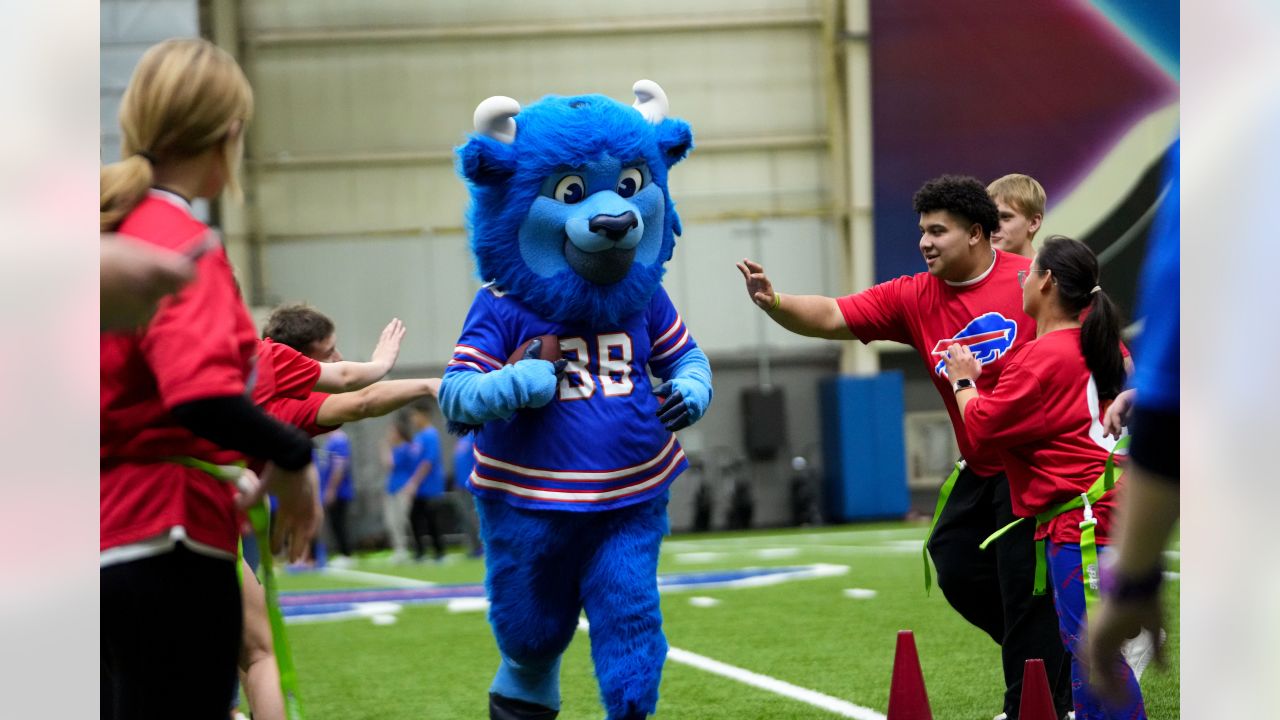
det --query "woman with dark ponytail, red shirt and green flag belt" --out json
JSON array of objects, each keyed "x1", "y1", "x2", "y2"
[{"x1": 945, "y1": 236, "x2": 1146, "y2": 720}]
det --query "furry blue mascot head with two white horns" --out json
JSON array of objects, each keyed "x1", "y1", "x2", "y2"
[{"x1": 458, "y1": 79, "x2": 692, "y2": 324}]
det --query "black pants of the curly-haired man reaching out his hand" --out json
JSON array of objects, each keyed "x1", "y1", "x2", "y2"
[{"x1": 929, "y1": 468, "x2": 1071, "y2": 720}]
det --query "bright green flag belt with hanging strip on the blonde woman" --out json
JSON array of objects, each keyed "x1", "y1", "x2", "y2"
[{"x1": 168, "y1": 457, "x2": 302, "y2": 720}]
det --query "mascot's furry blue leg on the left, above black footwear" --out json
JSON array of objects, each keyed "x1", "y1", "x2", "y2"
[{"x1": 476, "y1": 500, "x2": 581, "y2": 720}]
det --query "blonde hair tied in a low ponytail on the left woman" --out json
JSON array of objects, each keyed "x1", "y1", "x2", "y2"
[{"x1": 99, "y1": 38, "x2": 253, "y2": 232}]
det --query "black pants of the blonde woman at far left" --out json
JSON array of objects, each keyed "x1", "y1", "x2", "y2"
[{"x1": 99, "y1": 543, "x2": 242, "y2": 720}]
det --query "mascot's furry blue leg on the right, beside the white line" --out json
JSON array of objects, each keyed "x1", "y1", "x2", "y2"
[{"x1": 582, "y1": 495, "x2": 667, "y2": 720}]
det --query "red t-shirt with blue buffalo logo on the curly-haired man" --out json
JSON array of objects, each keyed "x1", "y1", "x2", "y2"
[{"x1": 836, "y1": 250, "x2": 1036, "y2": 475}]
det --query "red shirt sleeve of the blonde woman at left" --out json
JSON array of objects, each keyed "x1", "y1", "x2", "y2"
[{"x1": 140, "y1": 249, "x2": 253, "y2": 409}]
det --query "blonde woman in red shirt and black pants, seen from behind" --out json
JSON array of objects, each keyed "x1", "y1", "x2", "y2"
[{"x1": 99, "y1": 38, "x2": 321, "y2": 720}]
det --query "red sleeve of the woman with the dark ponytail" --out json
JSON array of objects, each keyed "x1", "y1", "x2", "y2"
[{"x1": 964, "y1": 363, "x2": 1047, "y2": 447}]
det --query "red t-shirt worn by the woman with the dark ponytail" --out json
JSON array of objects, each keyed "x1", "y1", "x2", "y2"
[{"x1": 965, "y1": 328, "x2": 1123, "y2": 543}]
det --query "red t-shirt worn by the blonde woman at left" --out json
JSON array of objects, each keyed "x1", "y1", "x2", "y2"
[{"x1": 99, "y1": 191, "x2": 257, "y2": 557}]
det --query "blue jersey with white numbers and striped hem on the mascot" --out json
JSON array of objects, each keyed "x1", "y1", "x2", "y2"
[{"x1": 445, "y1": 286, "x2": 696, "y2": 511}]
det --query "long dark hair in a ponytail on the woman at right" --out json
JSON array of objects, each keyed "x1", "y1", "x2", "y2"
[{"x1": 1036, "y1": 234, "x2": 1125, "y2": 400}]
